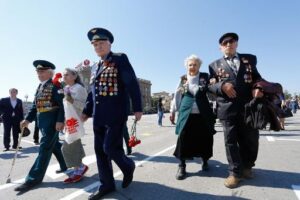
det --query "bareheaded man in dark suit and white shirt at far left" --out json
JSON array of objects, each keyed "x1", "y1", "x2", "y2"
[{"x1": 0, "y1": 88, "x2": 24, "y2": 151}]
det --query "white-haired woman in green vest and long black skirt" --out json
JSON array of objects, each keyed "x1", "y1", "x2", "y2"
[{"x1": 170, "y1": 55, "x2": 215, "y2": 180}]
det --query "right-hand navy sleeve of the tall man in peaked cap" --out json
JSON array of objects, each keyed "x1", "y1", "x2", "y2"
[{"x1": 118, "y1": 54, "x2": 142, "y2": 112}]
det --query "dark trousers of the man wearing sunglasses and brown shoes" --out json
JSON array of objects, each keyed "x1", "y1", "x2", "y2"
[{"x1": 221, "y1": 117, "x2": 259, "y2": 177}]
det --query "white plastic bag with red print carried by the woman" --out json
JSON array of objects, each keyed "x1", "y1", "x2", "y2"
[{"x1": 64, "y1": 101, "x2": 85, "y2": 144}]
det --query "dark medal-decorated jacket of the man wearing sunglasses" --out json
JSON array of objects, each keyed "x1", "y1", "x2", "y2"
[{"x1": 209, "y1": 54, "x2": 261, "y2": 120}]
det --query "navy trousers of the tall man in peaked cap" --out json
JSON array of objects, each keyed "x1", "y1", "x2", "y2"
[{"x1": 94, "y1": 122, "x2": 134, "y2": 189}]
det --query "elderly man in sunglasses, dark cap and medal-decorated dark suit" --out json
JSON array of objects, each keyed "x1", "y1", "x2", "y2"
[{"x1": 209, "y1": 33, "x2": 263, "y2": 188}]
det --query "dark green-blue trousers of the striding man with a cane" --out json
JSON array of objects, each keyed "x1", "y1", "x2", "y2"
[{"x1": 26, "y1": 127, "x2": 67, "y2": 183}]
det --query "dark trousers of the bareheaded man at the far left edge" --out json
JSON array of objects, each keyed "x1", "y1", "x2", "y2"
[{"x1": 3, "y1": 117, "x2": 21, "y2": 149}]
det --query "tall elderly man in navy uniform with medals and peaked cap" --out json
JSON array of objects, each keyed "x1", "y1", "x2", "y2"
[{"x1": 82, "y1": 28, "x2": 142, "y2": 200}]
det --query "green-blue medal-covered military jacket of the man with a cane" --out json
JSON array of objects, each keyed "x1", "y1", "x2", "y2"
[{"x1": 25, "y1": 79, "x2": 65, "y2": 128}]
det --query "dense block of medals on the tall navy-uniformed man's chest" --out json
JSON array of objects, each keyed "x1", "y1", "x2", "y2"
[{"x1": 99, "y1": 67, "x2": 118, "y2": 96}]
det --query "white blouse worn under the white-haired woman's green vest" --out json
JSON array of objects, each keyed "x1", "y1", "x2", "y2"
[{"x1": 170, "y1": 72, "x2": 200, "y2": 113}]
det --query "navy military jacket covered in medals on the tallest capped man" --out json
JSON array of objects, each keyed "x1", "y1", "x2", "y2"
[{"x1": 83, "y1": 52, "x2": 142, "y2": 126}]
